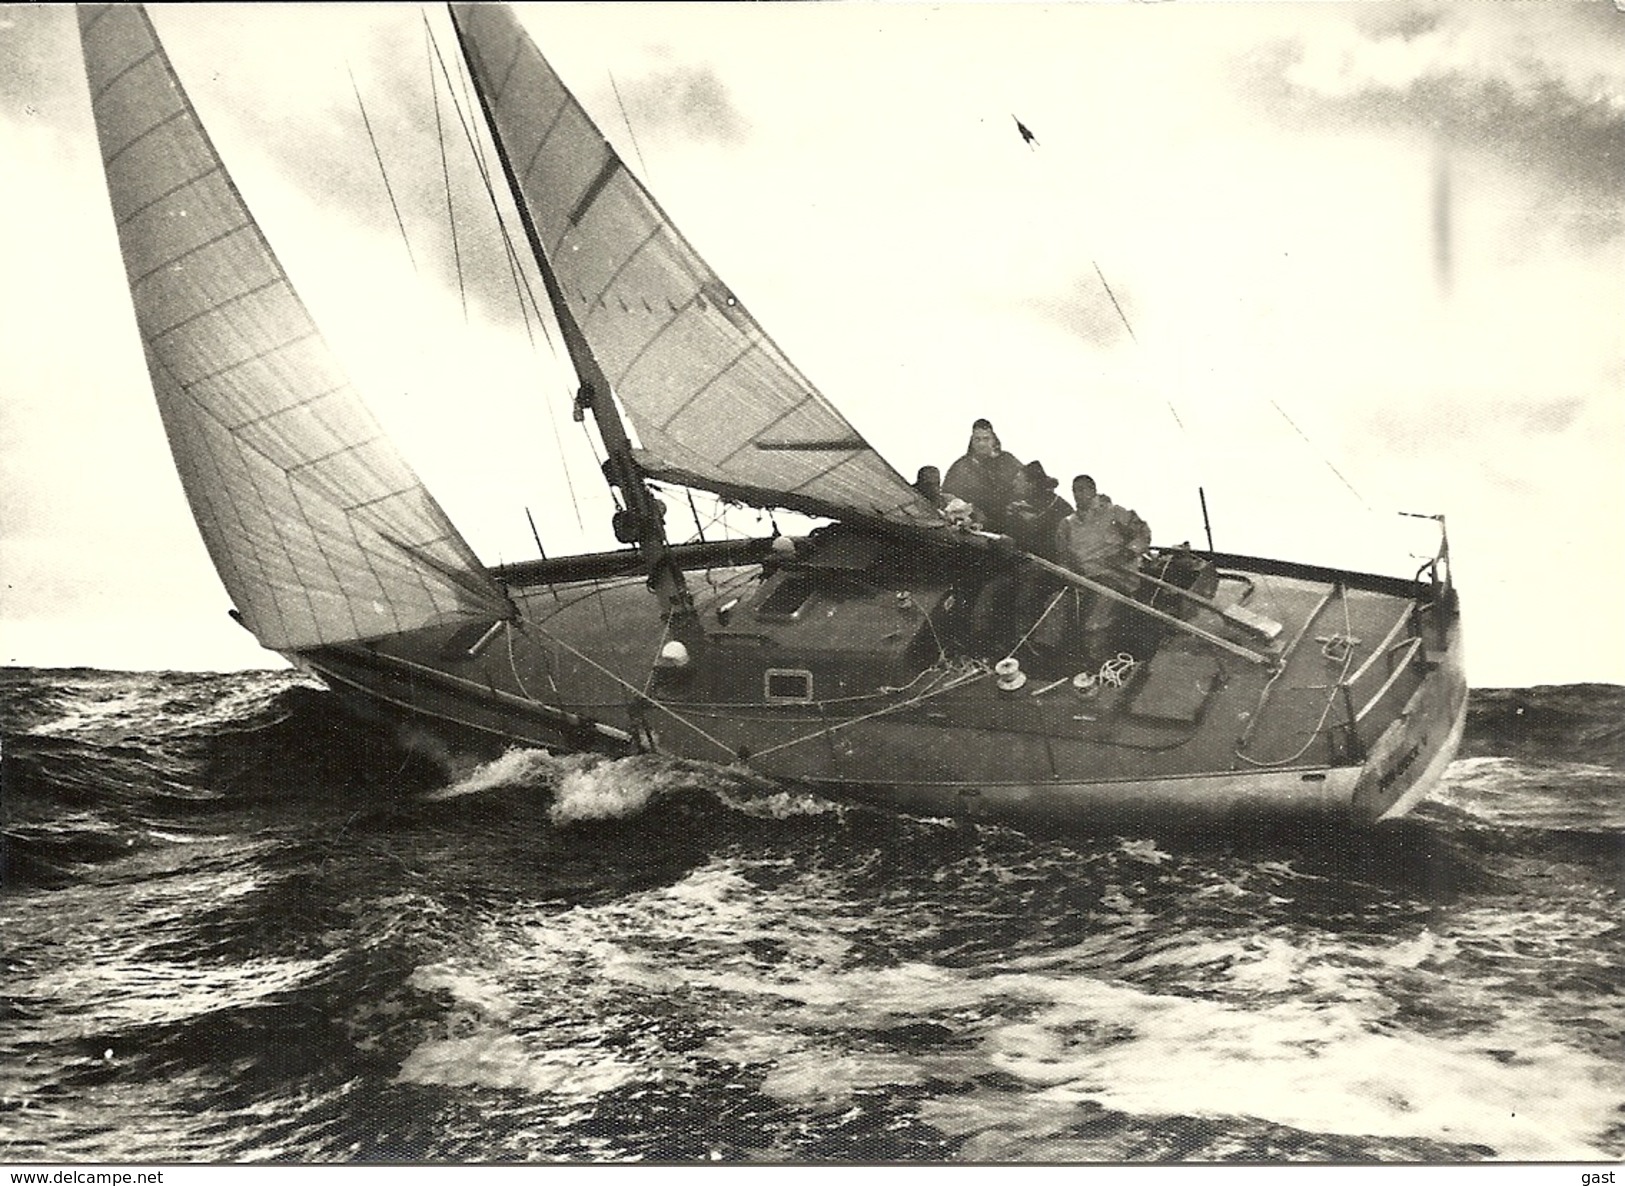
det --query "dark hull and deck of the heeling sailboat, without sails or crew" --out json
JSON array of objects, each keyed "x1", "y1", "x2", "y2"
[{"x1": 299, "y1": 544, "x2": 1466, "y2": 827}]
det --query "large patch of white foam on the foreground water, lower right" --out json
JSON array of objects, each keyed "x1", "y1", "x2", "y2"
[{"x1": 412, "y1": 858, "x2": 1622, "y2": 1160}]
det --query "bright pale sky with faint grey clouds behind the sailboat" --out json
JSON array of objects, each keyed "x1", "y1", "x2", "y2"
[{"x1": 0, "y1": 0, "x2": 1625, "y2": 687}]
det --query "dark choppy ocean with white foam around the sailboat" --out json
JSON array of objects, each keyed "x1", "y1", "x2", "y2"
[{"x1": 0, "y1": 668, "x2": 1625, "y2": 1156}]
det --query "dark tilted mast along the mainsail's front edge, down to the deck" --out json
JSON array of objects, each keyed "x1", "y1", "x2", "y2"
[{"x1": 450, "y1": 13, "x2": 699, "y2": 627}]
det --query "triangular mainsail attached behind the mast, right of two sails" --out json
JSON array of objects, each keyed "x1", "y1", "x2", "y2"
[{"x1": 452, "y1": 3, "x2": 944, "y2": 526}]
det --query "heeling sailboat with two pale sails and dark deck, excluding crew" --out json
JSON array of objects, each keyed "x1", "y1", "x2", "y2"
[{"x1": 78, "y1": 5, "x2": 1467, "y2": 827}]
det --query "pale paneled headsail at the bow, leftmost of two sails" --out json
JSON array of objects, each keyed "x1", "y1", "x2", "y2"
[{"x1": 80, "y1": 5, "x2": 507, "y2": 650}]
